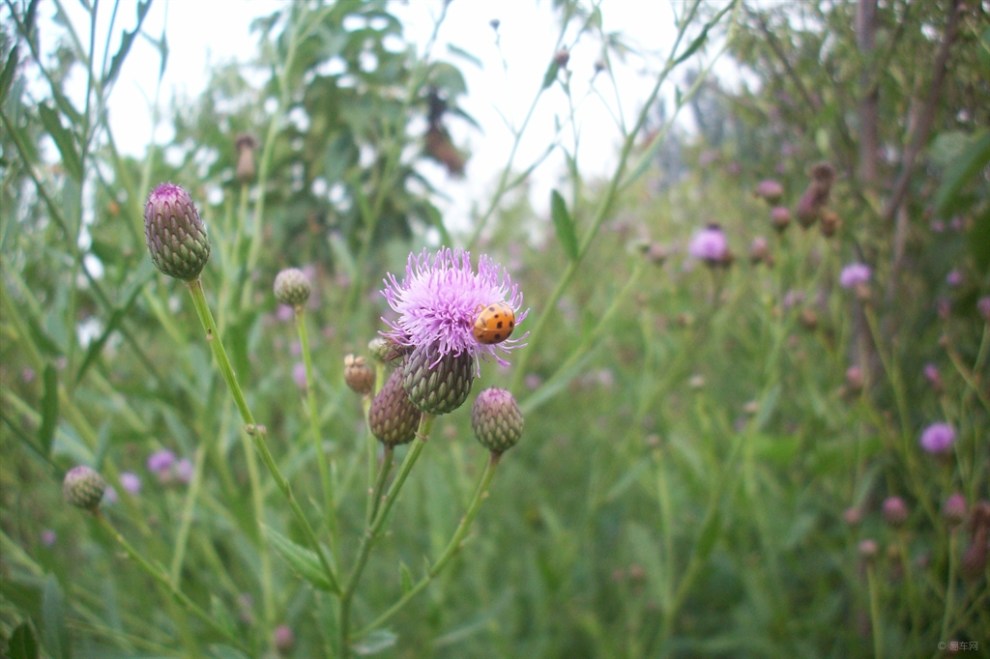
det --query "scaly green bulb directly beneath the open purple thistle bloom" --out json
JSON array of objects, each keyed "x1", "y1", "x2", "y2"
[{"x1": 402, "y1": 345, "x2": 474, "y2": 414}]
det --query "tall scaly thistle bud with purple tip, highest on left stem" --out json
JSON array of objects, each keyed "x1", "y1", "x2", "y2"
[{"x1": 144, "y1": 183, "x2": 210, "y2": 281}]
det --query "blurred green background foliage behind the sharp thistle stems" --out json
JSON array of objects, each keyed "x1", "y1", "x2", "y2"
[{"x1": 0, "y1": 0, "x2": 990, "y2": 657}]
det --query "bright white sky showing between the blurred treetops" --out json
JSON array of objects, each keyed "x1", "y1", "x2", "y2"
[{"x1": 52, "y1": 0, "x2": 721, "y2": 223}]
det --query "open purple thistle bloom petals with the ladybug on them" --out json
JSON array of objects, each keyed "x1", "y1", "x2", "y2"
[{"x1": 382, "y1": 247, "x2": 529, "y2": 368}]
